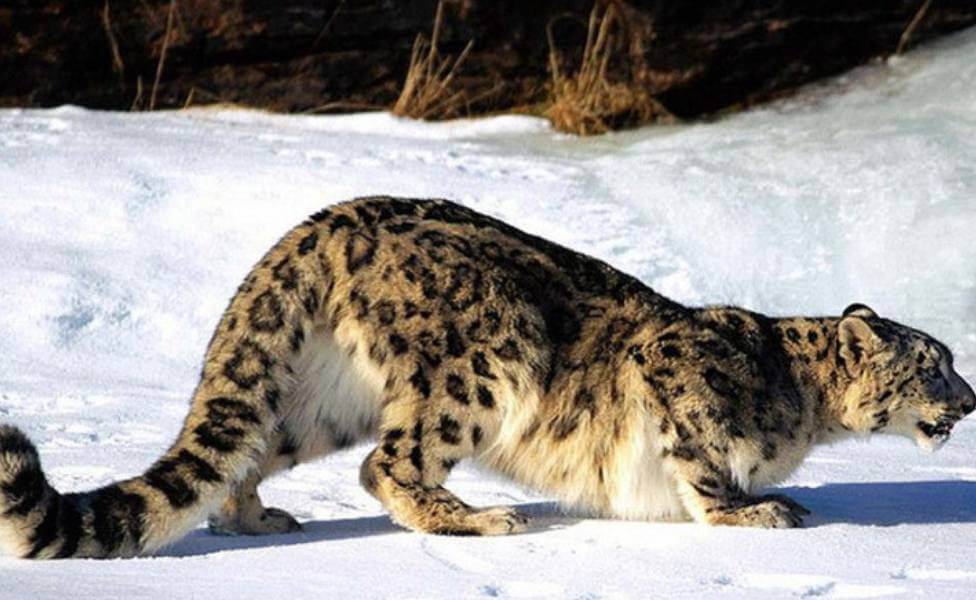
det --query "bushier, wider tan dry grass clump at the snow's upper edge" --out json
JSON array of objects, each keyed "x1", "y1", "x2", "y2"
[{"x1": 546, "y1": 2, "x2": 673, "y2": 135}]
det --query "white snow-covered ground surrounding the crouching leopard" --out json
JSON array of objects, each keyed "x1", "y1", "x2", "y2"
[{"x1": 0, "y1": 23, "x2": 976, "y2": 600}]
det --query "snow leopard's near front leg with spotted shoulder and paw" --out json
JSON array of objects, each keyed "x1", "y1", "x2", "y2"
[{"x1": 643, "y1": 332, "x2": 810, "y2": 528}]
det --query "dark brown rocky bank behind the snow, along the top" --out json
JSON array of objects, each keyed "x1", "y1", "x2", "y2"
[{"x1": 0, "y1": 0, "x2": 976, "y2": 126}]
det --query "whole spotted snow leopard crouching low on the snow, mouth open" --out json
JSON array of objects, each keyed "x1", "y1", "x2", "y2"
[{"x1": 0, "y1": 197, "x2": 976, "y2": 559}]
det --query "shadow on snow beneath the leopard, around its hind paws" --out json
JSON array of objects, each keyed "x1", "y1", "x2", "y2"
[{"x1": 156, "y1": 502, "x2": 578, "y2": 557}]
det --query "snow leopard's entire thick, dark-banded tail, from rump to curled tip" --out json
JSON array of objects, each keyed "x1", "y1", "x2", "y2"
[{"x1": 0, "y1": 211, "x2": 345, "y2": 559}]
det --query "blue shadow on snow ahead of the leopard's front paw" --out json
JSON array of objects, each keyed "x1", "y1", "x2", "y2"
[{"x1": 775, "y1": 480, "x2": 976, "y2": 527}]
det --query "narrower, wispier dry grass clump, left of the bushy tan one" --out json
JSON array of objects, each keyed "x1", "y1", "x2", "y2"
[{"x1": 393, "y1": 0, "x2": 474, "y2": 119}]
